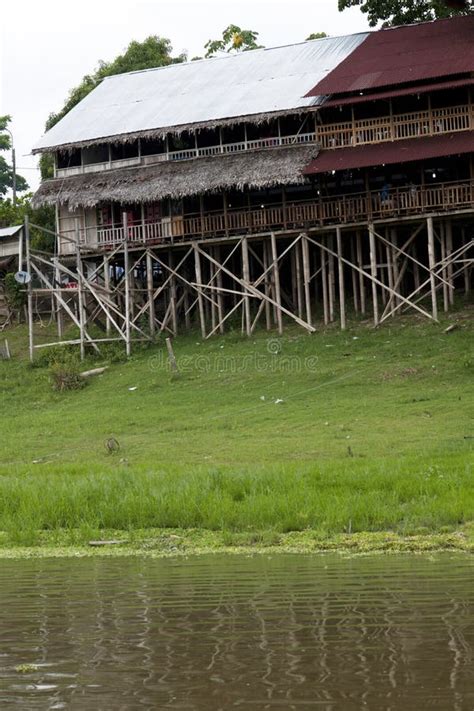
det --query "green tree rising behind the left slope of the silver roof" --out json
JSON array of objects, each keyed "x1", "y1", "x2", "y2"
[{"x1": 40, "y1": 35, "x2": 187, "y2": 180}]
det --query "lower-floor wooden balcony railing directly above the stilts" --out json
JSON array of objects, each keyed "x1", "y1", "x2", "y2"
[{"x1": 83, "y1": 181, "x2": 474, "y2": 249}]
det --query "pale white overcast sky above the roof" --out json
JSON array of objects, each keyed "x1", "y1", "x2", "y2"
[{"x1": 0, "y1": 0, "x2": 368, "y2": 189}]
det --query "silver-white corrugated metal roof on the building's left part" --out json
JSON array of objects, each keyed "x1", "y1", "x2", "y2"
[{"x1": 34, "y1": 33, "x2": 367, "y2": 150}]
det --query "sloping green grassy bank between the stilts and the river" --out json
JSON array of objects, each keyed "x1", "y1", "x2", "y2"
[{"x1": 0, "y1": 308, "x2": 474, "y2": 556}]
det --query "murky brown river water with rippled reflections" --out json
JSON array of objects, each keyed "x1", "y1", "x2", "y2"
[{"x1": 0, "y1": 554, "x2": 474, "y2": 711}]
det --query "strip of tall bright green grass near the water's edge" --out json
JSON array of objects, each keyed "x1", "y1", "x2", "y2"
[{"x1": 0, "y1": 457, "x2": 474, "y2": 537}]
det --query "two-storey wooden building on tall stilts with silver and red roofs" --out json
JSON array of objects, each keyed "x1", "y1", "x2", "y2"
[{"x1": 26, "y1": 16, "x2": 474, "y2": 354}]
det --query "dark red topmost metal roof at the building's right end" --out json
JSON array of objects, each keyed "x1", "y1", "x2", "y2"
[{"x1": 306, "y1": 15, "x2": 474, "y2": 97}]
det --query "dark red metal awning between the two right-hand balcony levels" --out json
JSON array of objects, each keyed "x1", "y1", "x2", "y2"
[{"x1": 304, "y1": 131, "x2": 474, "y2": 175}]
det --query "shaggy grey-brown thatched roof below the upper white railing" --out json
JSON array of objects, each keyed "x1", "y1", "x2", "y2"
[{"x1": 33, "y1": 146, "x2": 317, "y2": 209}]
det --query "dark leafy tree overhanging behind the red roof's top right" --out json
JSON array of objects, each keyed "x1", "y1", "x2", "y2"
[{"x1": 338, "y1": 0, "x2": 473, "y2": 27}]
